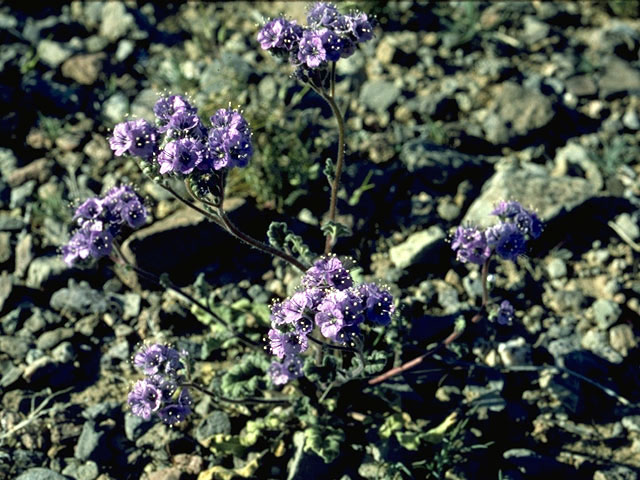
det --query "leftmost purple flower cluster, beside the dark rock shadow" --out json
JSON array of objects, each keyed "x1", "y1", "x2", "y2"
[{"x1": 62, "y1": 185, "x2": 147, "y2": 266}]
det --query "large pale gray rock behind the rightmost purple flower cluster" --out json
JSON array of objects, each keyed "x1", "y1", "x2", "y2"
[{"x1": 464, "y1": 163, "x2": 595, "y2": 227}]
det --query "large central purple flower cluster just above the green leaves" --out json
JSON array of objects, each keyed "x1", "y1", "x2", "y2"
[{"x1": 268, "y1": 256, "x2": 395, "y2": 385}]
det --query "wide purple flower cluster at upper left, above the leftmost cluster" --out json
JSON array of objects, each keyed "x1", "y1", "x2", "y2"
[{"x1": 109, "y1": 95, "x2": 253, "y2": 175}]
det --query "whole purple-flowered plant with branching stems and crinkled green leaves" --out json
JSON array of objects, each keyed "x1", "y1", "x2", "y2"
[{"x1": 56, "y1": 3, "x2": 620, "y2": 478}]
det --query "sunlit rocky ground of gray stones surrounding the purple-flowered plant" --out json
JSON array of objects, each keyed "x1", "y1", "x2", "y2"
[{"x1": 0, "y1": 0, "x2": 640, "y2": 480}]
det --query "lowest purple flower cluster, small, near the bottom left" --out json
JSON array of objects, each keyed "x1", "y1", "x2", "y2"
[{"x1": 128, "y1": 343, "x2": 193, "y2": 425}]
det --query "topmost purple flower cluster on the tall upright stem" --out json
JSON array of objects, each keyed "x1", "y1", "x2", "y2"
[{"x1": 258, "y1": 2, "x2": 373, "y2": 73}]
